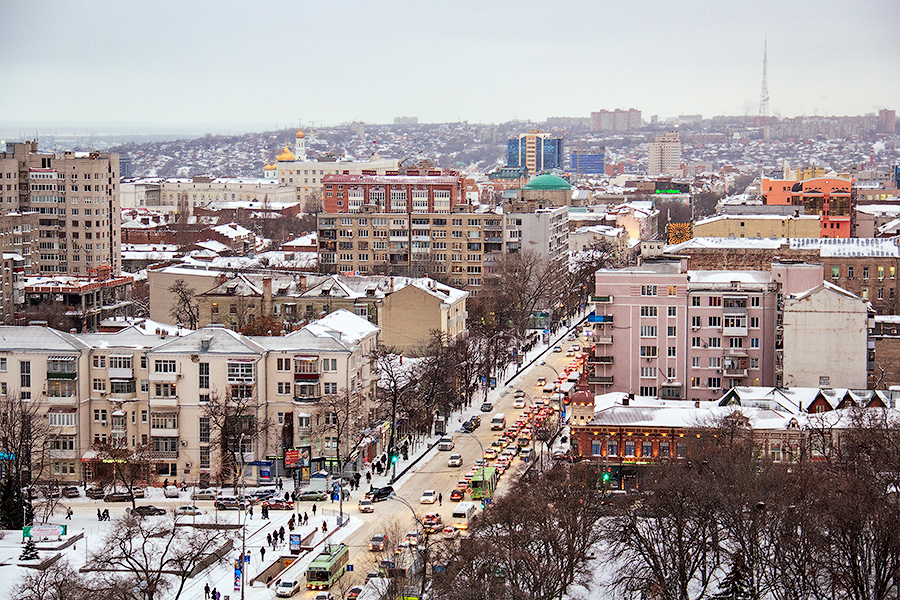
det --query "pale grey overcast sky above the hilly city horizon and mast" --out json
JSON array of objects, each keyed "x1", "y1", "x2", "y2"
[{"x1": 0, "y1": 0, "x2": 900, "y2": 129}]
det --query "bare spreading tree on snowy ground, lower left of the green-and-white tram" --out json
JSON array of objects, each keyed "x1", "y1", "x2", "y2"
[{"x1": 87, "y1": 512, "x2": 233, "y2": 600}]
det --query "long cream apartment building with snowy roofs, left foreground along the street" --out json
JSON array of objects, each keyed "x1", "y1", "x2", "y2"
[{"x1": 0, "y1": 311, "x2": 381, "y2": 482}]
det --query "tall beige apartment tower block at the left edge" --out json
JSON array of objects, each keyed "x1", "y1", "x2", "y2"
[{"x1": 0, "y1": 141, "x2": 122, "y2": 276}]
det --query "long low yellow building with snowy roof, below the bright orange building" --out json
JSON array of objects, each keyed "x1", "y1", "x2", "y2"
[{"x1": 694, "y1": 215, "x2": 821, "y2": 238}]
